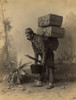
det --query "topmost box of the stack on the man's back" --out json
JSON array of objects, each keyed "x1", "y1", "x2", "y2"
[{"x1": 38, "y1": 14, "x2": 63, "y2": 27}]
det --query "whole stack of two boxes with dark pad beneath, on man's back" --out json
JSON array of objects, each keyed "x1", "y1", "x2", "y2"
[{"x1": 37, "y1": 14, "x2": 65, "y2": 50}]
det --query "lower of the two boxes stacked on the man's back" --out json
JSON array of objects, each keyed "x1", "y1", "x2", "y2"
[{"x1": 37, "y1": 26, "x2": 65, "y2": 38}]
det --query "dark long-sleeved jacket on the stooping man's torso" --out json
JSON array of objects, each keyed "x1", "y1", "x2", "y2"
[{"x1": 32, "y1": 35, "x2": 54, "y2": 65}]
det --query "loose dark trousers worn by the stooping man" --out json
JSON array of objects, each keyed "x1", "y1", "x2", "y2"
[{"x1": 39, "y1": 52, "x2": 55, "y2": 83}]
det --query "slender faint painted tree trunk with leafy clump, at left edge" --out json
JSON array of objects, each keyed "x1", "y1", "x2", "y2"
[{"x1": 0, "y1": 0, "x2": 11, "y2": 64}]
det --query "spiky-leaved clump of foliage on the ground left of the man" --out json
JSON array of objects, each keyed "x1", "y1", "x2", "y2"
[{"x1": 4, "y1": 61, "x2": 29, "y2": 85}]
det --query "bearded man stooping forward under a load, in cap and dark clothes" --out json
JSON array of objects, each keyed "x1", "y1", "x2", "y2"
[{"x1": 25, "y1": 28, "x2": 55, "y2": 89}]
